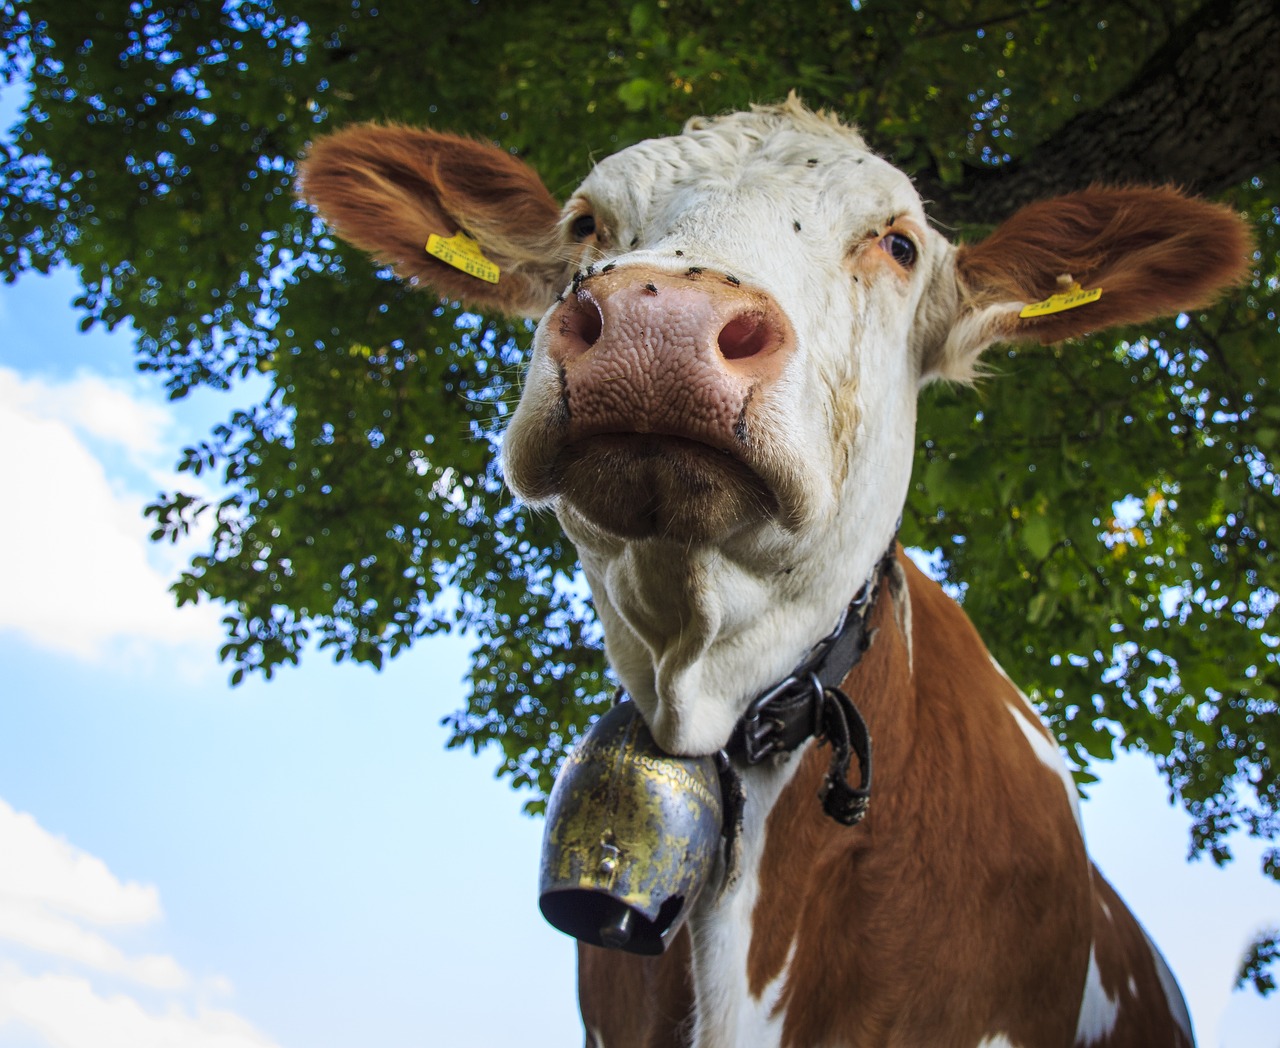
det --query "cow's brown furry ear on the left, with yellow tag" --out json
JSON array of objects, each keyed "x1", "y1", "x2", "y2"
[{"x1": 298, "y1": 124, "x2": 567, "y2": 316}]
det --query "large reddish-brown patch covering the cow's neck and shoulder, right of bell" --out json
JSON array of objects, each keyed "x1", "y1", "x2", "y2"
[{"x1": 748, "y1": 559, "x2": 1091, "y2": 1045}]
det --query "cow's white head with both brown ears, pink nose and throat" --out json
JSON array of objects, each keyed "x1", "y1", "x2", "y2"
[{"x1": 301, "y1": 100, "x2": 1248, "y2": 754}]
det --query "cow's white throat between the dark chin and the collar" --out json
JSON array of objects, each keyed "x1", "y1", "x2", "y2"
[{"x1": 561, "y1": 499, "x2": 896, "y2": 754}]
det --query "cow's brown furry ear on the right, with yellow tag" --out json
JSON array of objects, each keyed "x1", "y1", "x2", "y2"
[{"x1": 925, "y1": 187, "x2": 1252, "y2": 381}]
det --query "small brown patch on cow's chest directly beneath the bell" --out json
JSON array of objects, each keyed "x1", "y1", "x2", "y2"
[{"x1": 577, "y1": 929, "x2": 694, "y2": 1048}]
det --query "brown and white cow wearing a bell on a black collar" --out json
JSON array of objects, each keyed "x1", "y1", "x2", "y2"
[{"x1": 300, "y1": 96, "x2": 1251, "y2": 1048}]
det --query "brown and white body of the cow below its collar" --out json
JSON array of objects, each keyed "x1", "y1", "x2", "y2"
[{"x1": 580, "y1": 557, "x2": 1190, "y2": 1048}]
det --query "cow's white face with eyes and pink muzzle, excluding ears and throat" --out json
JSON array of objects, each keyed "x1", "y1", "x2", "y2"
[{"x1": 504, "y1": 107, "x2": 952, "y2": 560}]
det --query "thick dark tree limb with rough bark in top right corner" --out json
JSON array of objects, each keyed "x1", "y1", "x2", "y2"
[{"x1": 915, "y1": 0, "x2": 1280, "y2": 225}]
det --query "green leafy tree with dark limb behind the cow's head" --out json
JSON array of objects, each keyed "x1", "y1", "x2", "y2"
[{"x1": 0, "y1": 0, "x2": 1280, "y2": 987}]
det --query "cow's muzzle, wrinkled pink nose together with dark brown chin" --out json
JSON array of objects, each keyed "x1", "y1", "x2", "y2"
[{"x1": 508, "y1": 265, "x2": 795, "y2": 541}]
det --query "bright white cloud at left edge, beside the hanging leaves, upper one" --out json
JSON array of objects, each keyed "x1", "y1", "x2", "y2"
[{"x1": 0, "y1": 367, "x2": 220, "y2": 662}]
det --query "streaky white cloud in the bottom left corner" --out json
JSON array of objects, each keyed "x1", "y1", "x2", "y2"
[{"x1": 0, "y1": 800, "x2": 282, "y2": 1048}]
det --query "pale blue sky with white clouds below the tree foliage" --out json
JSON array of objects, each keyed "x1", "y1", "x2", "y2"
[{"x1": 0, "y1": 88, "x2": 1280, "y2": 1048}]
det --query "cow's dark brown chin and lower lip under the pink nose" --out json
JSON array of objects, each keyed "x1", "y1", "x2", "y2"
[{"x1": 554, "y1": 434, "x2": 777, "y2": 544}]
